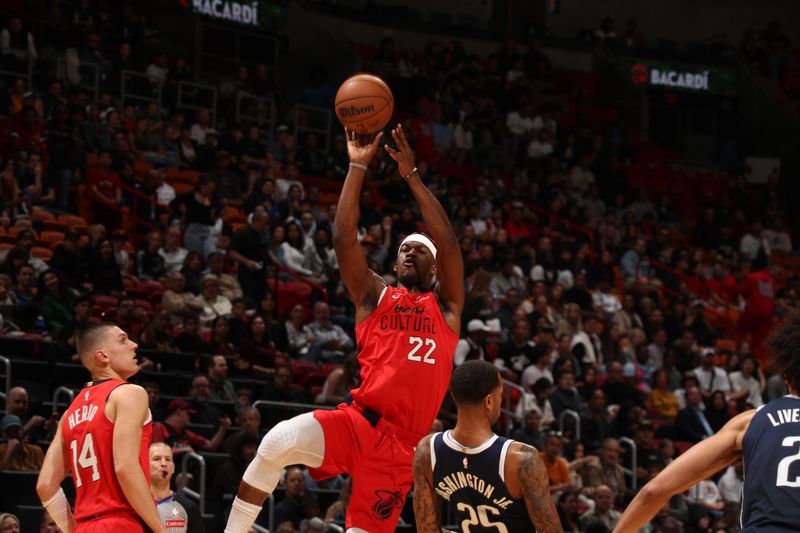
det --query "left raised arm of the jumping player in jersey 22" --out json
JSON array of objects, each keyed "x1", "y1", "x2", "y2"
[{"x1": 333, "y1": 128, "x2": 386, "y2": 322}]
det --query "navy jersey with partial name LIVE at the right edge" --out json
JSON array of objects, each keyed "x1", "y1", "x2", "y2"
[{"x1": 741, "y1": 396, "x2": 800, "y2": 533}]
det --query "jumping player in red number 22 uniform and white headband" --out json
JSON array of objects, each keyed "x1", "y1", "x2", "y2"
[{"x1": 225, "y1": 126, "x2": 464, "y2": 533}]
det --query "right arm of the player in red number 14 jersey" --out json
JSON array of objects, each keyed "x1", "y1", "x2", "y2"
[{"x1": 109, "y1": 385, "x2": 165, "y2": 533}]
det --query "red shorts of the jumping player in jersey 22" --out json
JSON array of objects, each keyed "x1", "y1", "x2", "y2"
[{"x1": 309, "y1": 404, "x2": 419, "y2": 533}]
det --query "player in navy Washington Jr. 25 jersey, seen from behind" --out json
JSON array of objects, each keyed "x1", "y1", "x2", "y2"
[{"x1": 414, "y1": 360, "x2": 563, "y2": 533}]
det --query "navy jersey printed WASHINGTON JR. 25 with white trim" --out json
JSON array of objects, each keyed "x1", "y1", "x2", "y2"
[{"x1": 431, "y1": 431, "x2": 535, "y2": 533}]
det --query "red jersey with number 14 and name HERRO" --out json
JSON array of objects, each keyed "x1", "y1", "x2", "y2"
[{"x1": 61, "y1": 379, "x2": 153, "y2": 521}]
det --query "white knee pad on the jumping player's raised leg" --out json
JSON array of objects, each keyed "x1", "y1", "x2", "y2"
[{"x1": 242, "y1": 413, "x2": 325, "y2": 494}]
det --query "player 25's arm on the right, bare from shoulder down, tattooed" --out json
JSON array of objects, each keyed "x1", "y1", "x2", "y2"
[{"x1": 505, "y1": 442, "x2": 564, "y2": 533}]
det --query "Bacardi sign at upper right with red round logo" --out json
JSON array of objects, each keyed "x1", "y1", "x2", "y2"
[{"x1": 630, "y1": 59, "x2": 736, "y2": 96}]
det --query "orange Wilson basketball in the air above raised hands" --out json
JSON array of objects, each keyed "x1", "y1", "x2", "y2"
[{"x1": 335, "y1": 74, "x2": 394, "y2": 134}]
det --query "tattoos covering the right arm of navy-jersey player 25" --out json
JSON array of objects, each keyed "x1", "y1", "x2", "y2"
[{"x1": 517, "y1": 448, "x2": 564, "y2": 533}]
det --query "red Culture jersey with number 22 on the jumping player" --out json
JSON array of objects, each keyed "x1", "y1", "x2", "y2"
[{"x1": 351, "y1": 287, "x2": 458, "y2": 435}]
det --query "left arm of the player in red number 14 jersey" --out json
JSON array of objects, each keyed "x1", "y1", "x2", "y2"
[{"x1": 36, "y1": 421, "x2": 75, "y2": 533}]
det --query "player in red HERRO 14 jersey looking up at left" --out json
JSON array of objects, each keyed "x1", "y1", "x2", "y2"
[{"x1": 36, "y1": 322, "x2": 166, "y2": 533}]
